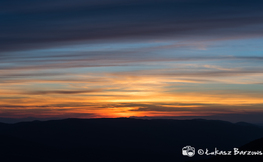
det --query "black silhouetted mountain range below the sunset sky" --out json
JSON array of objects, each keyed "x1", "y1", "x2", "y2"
[{"x1": 0, "y1": 118, "x2": 263, "y2": 162}]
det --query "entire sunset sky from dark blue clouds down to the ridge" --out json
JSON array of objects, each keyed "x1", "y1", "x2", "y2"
[{"x1": 0, "y1": 0, "x2": 263, "y2": 122}]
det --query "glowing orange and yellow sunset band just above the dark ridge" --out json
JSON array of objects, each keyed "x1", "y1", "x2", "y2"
[{"x1": 0, "y1": 71, "x2": 263, "y2": 118}]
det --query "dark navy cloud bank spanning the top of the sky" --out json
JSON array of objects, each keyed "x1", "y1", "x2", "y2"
[{"x1": 0, "y1": 0, "x2": 263, "y2": 51}]
